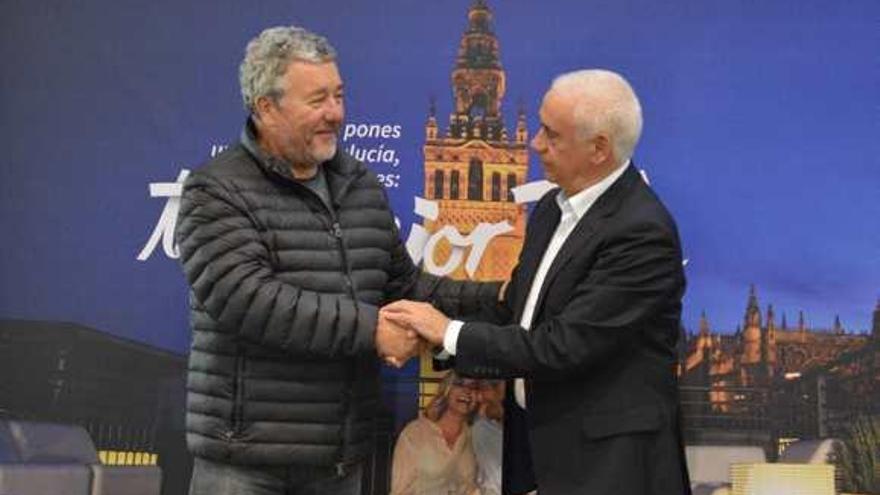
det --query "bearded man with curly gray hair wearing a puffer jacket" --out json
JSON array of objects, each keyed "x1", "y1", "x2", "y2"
[{"x1": 176, "y1": 26, "x2": 500, "y2": 495}]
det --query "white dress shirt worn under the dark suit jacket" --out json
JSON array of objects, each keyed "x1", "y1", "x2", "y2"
[{"x1": 443, "y1": 160, "x2": 630, "y2": 408}]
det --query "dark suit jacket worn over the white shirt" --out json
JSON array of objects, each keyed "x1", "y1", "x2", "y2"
[{"x1": 455, "y1": 165, "x2": 690, "y2": 495}]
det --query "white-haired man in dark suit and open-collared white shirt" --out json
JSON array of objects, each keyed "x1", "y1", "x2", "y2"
[{"x1": 382, "y1": 70, "x2": 690, "y2": 495}]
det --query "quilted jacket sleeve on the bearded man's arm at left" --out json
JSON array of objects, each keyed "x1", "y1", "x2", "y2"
[{"x1": 175, "y1": 173, "x2": 378, "y2": 358}]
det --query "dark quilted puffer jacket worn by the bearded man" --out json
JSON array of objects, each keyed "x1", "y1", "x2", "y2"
[{"x1": 176, "y1": 140, "x2": 498, "y2": 466}]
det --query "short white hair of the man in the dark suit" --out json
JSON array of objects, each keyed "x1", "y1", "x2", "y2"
[{"x1": 551, "y1": 69, "x2": 642, "y2": 165}]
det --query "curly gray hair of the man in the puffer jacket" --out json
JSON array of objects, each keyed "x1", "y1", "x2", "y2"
[{"x1": 238, "y1": 26, "x2": 336, "y2": 113}]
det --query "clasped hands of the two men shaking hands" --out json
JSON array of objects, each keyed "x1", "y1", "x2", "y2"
[{"x1": 376, "y1": 300, "x2": 449, "y2": 368}]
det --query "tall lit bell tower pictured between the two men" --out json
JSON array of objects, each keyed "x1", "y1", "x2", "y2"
[{"x1": 423, "y1": 0, "x2": 528, "y2": 280}]
